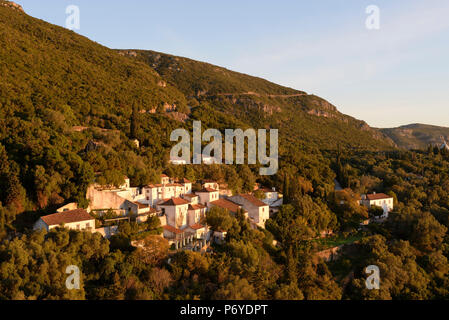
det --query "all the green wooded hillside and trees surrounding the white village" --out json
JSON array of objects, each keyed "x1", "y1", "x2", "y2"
[{"x1": 0, "y1": 1, "x2": 449, "y2": 300}]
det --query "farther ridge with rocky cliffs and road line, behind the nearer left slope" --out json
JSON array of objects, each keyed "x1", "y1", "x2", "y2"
[{"x1": 120, "y1": 50, "x2": 394, "y2": 150}]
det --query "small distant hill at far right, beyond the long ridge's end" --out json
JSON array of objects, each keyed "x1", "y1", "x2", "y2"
[{"x1": 380, "y1": 124, "x2": 449, "y2": 149}]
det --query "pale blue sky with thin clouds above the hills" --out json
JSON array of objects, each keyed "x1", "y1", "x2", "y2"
[{"x1": 17, "y1": 0, "x2": 449, "y2": 127}]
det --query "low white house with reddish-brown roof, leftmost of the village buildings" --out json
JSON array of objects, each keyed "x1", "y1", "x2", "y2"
[{"x1": 33, "y1": 209, "x2": 95, "y2": 232}]
